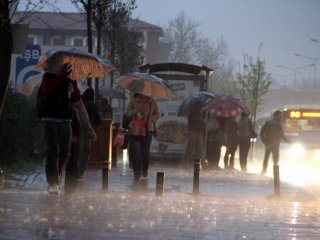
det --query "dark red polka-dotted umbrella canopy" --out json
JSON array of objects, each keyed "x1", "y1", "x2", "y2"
[{"x1": 204, "y1": 95, "x2": 247, "y2": 118}]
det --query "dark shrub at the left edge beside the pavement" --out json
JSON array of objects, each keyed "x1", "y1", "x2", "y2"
[{"x1": 0, "y1": 89, "x2": 42, "y2": 169}]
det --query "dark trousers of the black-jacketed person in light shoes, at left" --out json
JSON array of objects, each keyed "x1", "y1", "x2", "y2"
[{"x1": 43, "y1": 121, "x2": 72, "y2": 185}]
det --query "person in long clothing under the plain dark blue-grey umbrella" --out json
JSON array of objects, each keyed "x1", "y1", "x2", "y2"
[{"x1": 182, "y1": 99, "x2": 206, "y2": 166}]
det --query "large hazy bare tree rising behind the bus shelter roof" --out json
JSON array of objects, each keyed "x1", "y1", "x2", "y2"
[{"x1": 162, "y1": 12, "x2": 234, "y2": 92}]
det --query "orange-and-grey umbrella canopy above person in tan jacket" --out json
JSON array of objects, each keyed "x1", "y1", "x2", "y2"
[{"x1": 116, "y1": 72, "x2": 177, "y2": 99}]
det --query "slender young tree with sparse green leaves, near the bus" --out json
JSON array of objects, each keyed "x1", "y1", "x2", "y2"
[{"x1": 236, "y1": 52, "x2": 271, "y2": 122}]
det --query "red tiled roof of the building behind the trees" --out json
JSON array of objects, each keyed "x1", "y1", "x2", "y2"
[{"x1": 16, "y1": 12, "x2": 162, "y2": 32}]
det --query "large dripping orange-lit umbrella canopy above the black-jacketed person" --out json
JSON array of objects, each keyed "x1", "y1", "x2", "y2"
[{"x1": 37, "y1": 48, "x2": 115, "y2": 80}]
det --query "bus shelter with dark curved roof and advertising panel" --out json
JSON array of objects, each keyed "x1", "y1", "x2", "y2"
[{"x1": 139, "y1": 63, "x2": 213, "y2": 164}]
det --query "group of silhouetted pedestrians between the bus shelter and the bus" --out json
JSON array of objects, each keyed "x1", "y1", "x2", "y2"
[{"x1": 182, "y1": 107, "x2": 290, "y2": 175}]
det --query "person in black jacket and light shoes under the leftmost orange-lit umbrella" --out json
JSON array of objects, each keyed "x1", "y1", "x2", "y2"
[{"x1": 36, "y1": 64, "x2": 72, "y2": 194}]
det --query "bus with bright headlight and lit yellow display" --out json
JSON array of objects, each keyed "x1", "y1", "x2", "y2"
[{"x1": 280, "y1": 105, "x2": 320, "y2": 160}]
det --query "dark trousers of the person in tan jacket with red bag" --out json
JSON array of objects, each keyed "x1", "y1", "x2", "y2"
[{"x1": 129, "y1": 133, "x2": 152, "y2": 177}]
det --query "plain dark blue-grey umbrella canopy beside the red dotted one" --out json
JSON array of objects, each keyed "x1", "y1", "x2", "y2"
[{"x1": 177, "y1": 91, "x2": 216, "y2": 116}]
